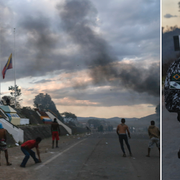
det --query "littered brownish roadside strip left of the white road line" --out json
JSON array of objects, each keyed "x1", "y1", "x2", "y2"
[{"x1": 0, "y1": 134, "x2": 88, "y2": 180}]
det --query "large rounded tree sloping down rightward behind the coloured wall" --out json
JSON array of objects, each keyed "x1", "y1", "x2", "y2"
[{"x1": 34, "y1": 93, "x2": 63, "y2": 122}]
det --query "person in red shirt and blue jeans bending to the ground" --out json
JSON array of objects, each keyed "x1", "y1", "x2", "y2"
[{"x1": 20, "y1": 137, "x2": 42, "y2": 167}]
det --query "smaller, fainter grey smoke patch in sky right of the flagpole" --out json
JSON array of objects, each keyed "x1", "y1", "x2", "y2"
[{"x1": 20, "y1": 14, "x2": 57, "y2": 67}]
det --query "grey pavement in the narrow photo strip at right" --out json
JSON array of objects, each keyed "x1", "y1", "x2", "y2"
[{"x1": 162, "y1": 103, "x2": 180, "y2": 180}]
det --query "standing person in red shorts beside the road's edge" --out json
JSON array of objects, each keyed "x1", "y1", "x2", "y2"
[{"x1": 51, "y1": 118, "x2": 60, "y2": 148}]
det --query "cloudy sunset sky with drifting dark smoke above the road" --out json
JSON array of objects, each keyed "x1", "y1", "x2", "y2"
[{"x1": 0, "y1": 0, "x2": 160, "y2": 118}]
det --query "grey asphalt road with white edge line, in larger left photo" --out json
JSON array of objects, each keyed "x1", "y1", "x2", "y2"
[{"x1": 27, "y1": 132, "x2": 160, "y2": 180}]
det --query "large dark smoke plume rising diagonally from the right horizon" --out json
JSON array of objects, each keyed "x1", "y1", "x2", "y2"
[{"x1": 57, "y1": 0, "x2": 159, "y2": 96}]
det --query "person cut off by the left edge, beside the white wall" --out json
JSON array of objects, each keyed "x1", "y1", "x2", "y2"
[{"x1": 0, "y1": 123, "x2": 12, "y2": 166}]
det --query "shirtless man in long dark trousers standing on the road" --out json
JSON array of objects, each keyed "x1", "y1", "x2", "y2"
[{"x1": 116, "y1": 118, "x2": 132, "y2": 157}]
